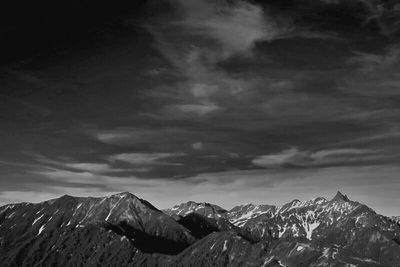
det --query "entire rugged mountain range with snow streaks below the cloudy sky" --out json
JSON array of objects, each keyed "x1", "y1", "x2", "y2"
[{"x1": 0, "y1": 192, "x2": 400, "y2": 267}]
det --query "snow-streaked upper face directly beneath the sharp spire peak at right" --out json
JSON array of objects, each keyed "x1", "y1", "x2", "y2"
[{"x1": 228, "y1": 192, "x2": 374, "y2": 240}]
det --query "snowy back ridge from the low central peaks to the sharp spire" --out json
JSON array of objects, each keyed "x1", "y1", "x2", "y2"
[{"x1": 164, "y1": 192, "x2": 363, "y2": 240}]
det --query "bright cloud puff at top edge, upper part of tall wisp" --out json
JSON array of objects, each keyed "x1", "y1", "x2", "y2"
[{"x1": 173, "y1": 0, "x2": 280, "y2": 57}]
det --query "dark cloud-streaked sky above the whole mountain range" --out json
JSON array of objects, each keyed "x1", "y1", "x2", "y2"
[{"x1": 0, "y1": 0, "x2": 400, "y2": 216}]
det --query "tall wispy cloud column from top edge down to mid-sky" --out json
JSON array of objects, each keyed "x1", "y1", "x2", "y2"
[{"x1": 144, "y1": 0, "x2": 288, "y2": 118}]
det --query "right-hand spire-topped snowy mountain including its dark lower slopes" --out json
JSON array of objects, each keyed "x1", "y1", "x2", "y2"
[{"x1": 165, "y1": 192, "x2": 400, "y2": 266}]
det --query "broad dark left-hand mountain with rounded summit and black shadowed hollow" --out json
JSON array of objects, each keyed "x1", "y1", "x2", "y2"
[{"x1": 0, "y1": 193, "x2": 195, "y2": 266}]
